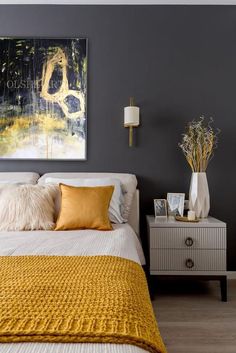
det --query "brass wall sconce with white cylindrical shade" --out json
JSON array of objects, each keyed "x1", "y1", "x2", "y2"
[{"x1": 124, "y1": 97, "x2": 139, "y2": 147}]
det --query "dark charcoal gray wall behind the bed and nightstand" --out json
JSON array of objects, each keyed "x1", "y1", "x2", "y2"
[{"x1": 0, "y1": 5, "x2": 236, "y2": 270}]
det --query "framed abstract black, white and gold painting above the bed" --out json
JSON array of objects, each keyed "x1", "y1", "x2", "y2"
[{"x1": 0, "y1": 38, "x2": 88, "y2": 160}]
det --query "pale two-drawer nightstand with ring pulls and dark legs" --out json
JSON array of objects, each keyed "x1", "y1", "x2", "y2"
[{"x1": 147, "y1": 216, "x2": 227, "y2": 301}]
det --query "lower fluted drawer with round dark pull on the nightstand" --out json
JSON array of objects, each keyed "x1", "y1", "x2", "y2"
[{"x1": 150, "y1": 249, "x2": 226, "y2": 272}]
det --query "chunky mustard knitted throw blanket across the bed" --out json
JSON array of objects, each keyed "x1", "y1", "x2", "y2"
[{"x1": 0, "y1": 256, "x2": 166, "y2": 353}]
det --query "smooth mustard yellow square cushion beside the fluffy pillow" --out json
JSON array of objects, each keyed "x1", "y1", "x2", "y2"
[{"x1": 55, "y1": 184, "x2": 114, "y2": 230}]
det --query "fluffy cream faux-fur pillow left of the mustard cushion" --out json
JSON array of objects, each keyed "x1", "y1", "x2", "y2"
[{"x1": 0, "y1": 184, "x2": 57, "y2": 231}]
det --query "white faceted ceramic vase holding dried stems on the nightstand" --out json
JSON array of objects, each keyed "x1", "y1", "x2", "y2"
[{"x1": 189, "y1": 173, "x2": 210, "y2": 218}]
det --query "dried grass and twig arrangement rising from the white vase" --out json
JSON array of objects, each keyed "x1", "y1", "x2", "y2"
[{"x1": 179, "y1": 116, "x2": 220, "y2": 173}]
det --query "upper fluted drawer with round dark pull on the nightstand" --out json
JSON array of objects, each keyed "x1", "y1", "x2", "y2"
[{"x1": 150, "y1": 227, "x2": 226, "y2": 249}]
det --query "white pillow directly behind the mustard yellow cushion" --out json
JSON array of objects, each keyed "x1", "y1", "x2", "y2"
[{"x1": 45, "y1": 177, "x2": 125, "y2": 223}]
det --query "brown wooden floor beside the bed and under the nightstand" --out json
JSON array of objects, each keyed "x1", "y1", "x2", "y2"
[{"x1": 153, "y1": 280, "x2": 236, "y2": 353}]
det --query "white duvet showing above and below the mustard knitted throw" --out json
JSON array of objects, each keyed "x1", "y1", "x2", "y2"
[{"x1": 0, "y1": 224, "x2": 146, "y2": 353}]
